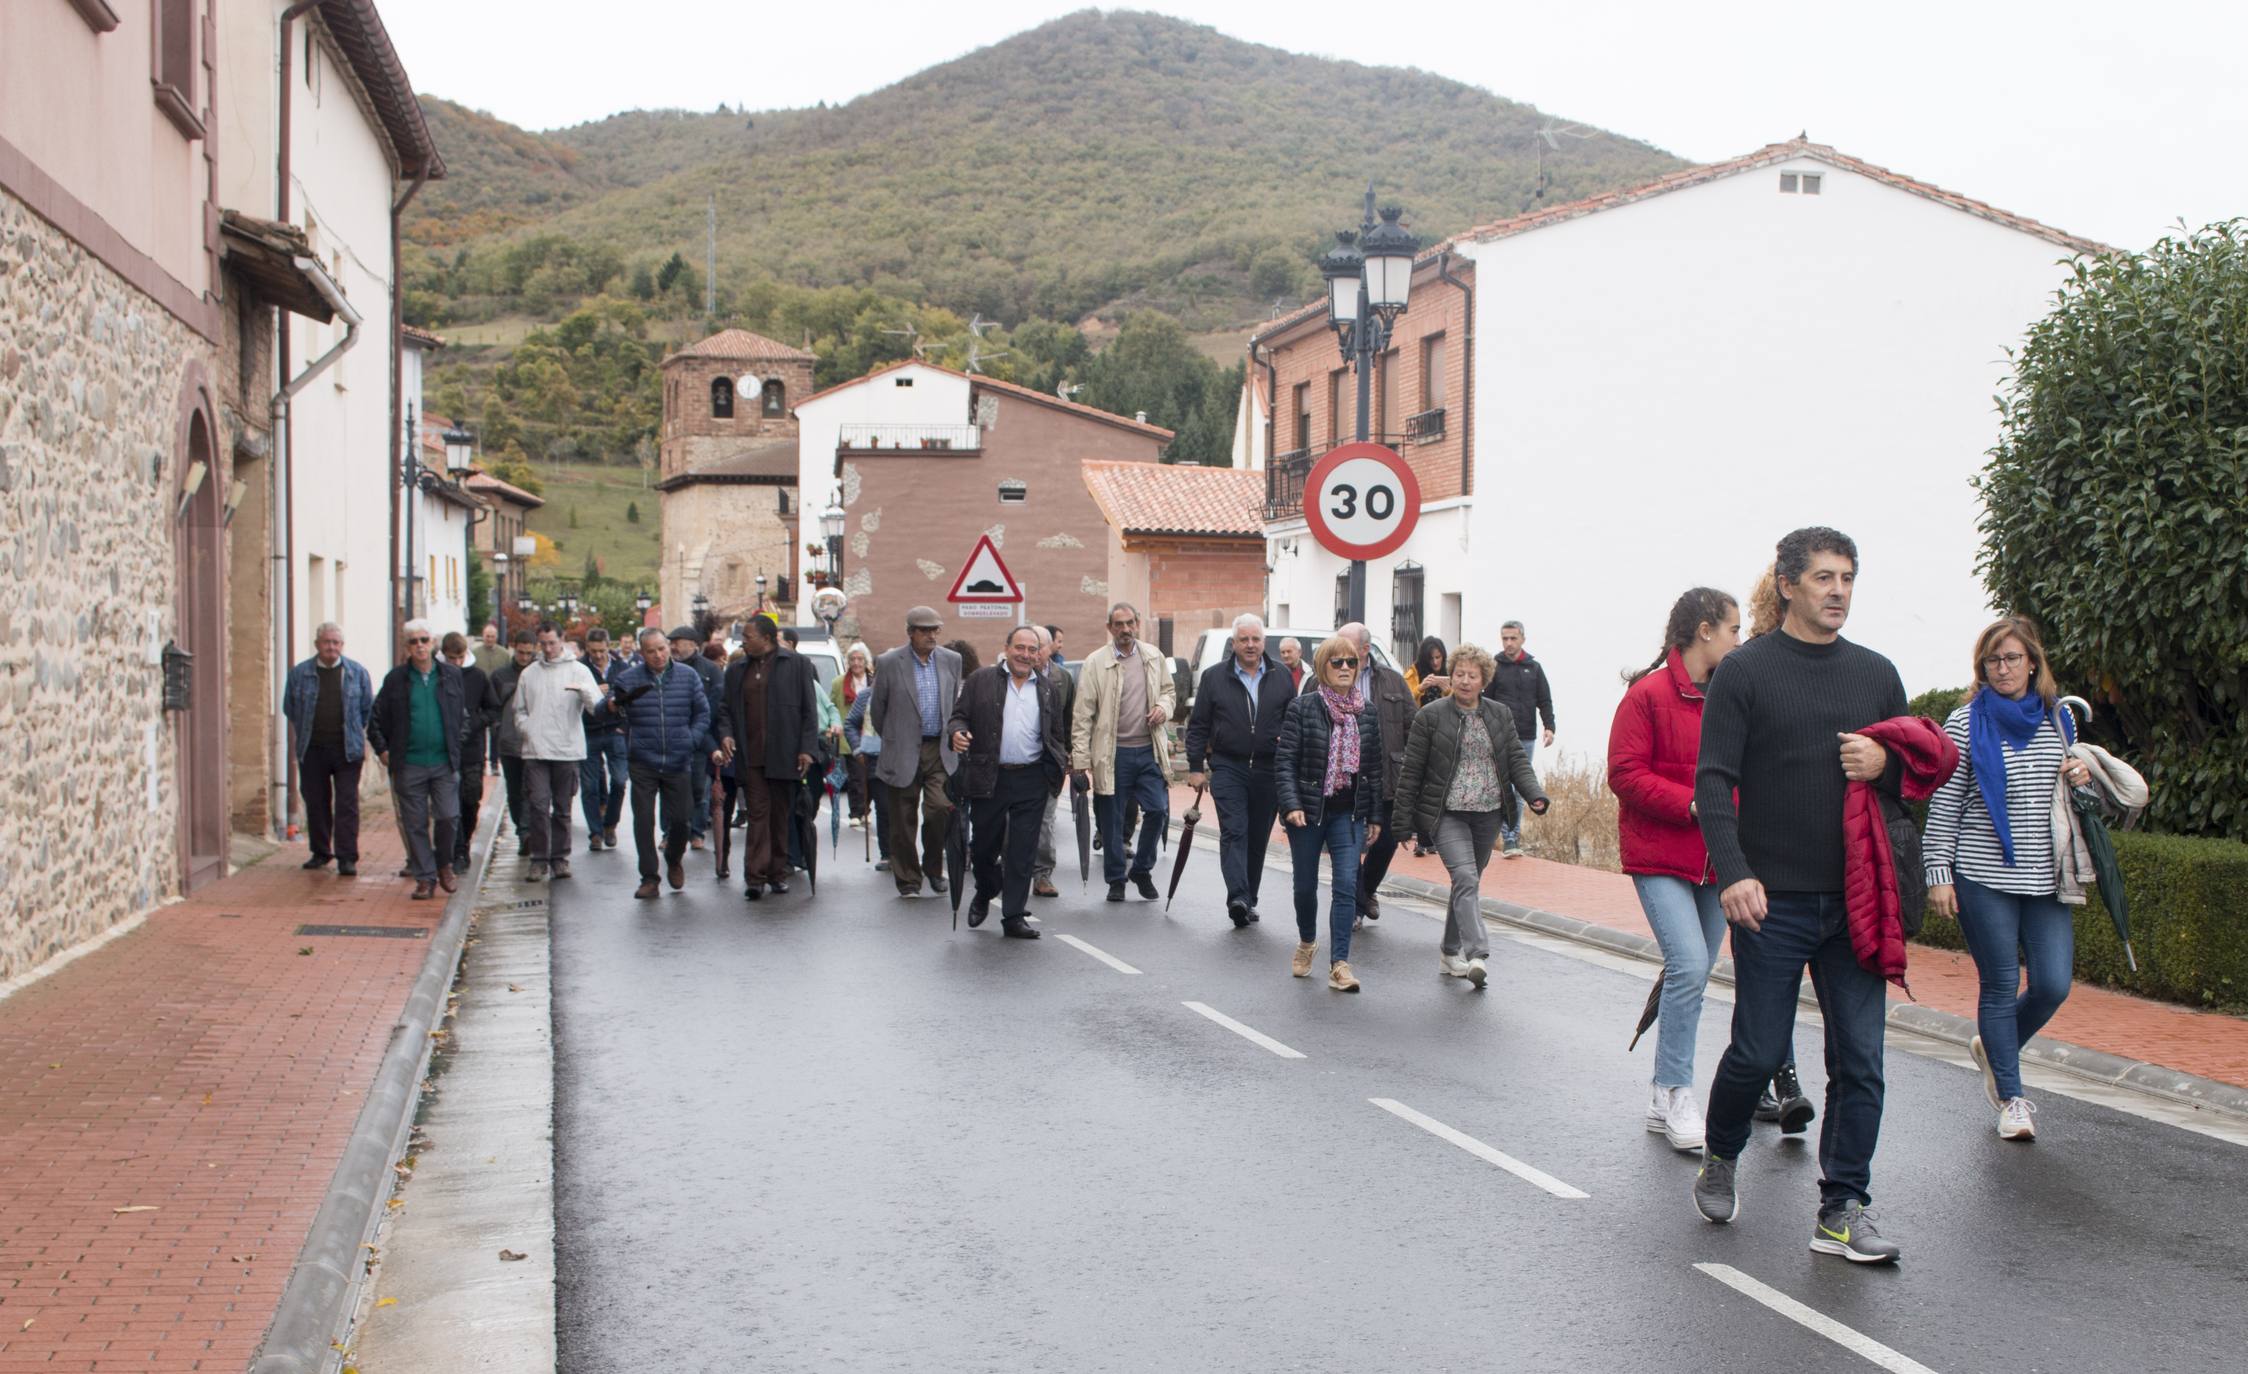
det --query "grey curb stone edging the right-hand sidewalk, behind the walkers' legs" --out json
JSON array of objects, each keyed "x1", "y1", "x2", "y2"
[{"x1": 1171, "y1": 816, "x2": 2248, "y2": 1120}]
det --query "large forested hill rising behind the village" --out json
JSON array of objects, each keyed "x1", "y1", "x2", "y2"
[{"x1": 407, "y1": 11, "x2": 1679, "y2": 331}]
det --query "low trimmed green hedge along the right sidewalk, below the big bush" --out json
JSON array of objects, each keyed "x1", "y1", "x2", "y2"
[{"x1": 1920, "y1": 832, "x2": 2248, "y2": 1007}]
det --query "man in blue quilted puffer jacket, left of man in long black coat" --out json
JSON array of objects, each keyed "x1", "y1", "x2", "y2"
[{"x1": 589, "y1": 627, "x2": 713, "y2": 902}]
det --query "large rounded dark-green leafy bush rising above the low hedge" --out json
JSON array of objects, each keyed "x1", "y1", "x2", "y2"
[{"x1": 1976, "y1": 220, "x2": 2248, "y2": 839}]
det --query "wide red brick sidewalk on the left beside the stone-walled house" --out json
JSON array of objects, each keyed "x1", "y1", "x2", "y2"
[{"x1": 0, "y1": 823, "x2": 445, "y2": 1374}]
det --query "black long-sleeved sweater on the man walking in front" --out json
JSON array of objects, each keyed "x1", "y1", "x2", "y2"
[{"x1": 1693, "y1": 630, "x2": 1904, "y2": 893}]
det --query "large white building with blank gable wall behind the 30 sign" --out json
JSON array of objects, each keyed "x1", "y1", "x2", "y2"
[{"x1": 1268, "y1": 139, "x2": 2111, "y2": 762}]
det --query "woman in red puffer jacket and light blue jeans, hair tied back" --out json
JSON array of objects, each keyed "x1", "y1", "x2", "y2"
[{"x1": 1607, "y1": 587, "x2": 1812, "y2": 1151}]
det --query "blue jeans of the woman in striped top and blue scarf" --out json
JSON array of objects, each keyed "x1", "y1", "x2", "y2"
[{"x1": 1958, "y1": 877, "x2": 2077, "y2": 1097}]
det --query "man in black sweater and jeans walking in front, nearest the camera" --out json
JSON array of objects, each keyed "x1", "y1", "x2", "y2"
[{"x1": 1693, "y1": 526, "x2": 1904, "y2": 1264}]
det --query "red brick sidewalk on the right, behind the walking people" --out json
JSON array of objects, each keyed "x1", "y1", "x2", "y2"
[{"x1": 1171, "y1": 787, "x2": 2248, "y2": 1086}]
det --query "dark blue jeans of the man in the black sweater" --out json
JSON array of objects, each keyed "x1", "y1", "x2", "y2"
[{"x1": 1708, "y1": 893, "x2": 1888, "y2": 1208}]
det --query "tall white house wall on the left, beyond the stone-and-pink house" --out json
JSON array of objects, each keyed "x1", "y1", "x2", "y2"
[{"x1": 218, "y1": 0, "x2": 398, "y2": 670}]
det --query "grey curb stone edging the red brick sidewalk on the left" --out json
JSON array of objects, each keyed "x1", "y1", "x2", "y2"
[{"x1": 250, "y1": 807, "x2": 506, "y2": 1374}]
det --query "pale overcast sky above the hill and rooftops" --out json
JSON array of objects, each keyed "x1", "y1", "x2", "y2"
[{"x1": 380, "y1": 0, "x2": 2248, "y2": 247}]
